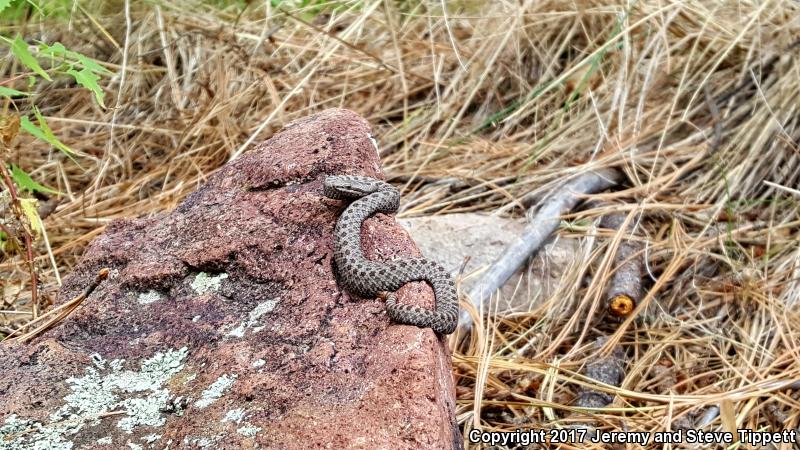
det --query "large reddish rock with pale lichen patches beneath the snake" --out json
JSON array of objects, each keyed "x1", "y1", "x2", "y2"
[{"x1": 0, "y1": 109, "x2": 462, "y2": 450}]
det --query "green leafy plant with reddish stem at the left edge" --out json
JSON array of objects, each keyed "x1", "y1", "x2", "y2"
[{"x1": 0, "y1": 0, "x2": 113, "y2": 319}]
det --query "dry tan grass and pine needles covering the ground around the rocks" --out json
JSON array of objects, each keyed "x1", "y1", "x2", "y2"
[{"x1": 0, "y1": 0, "x2": 800, "y2": 448}]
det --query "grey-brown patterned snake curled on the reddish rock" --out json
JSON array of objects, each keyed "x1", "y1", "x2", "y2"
[{"x1": 323, "y1": 175, "x2": 458, "y2": 335}]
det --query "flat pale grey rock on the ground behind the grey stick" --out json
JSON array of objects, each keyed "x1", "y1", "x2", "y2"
[{"x1": 398, "y1": 213, "x2": 578, "y2": 313}]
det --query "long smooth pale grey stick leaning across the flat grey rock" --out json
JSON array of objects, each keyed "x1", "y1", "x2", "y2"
[{"x1": 459, "y1": 169, "x2": 622, "y2": 331}]
